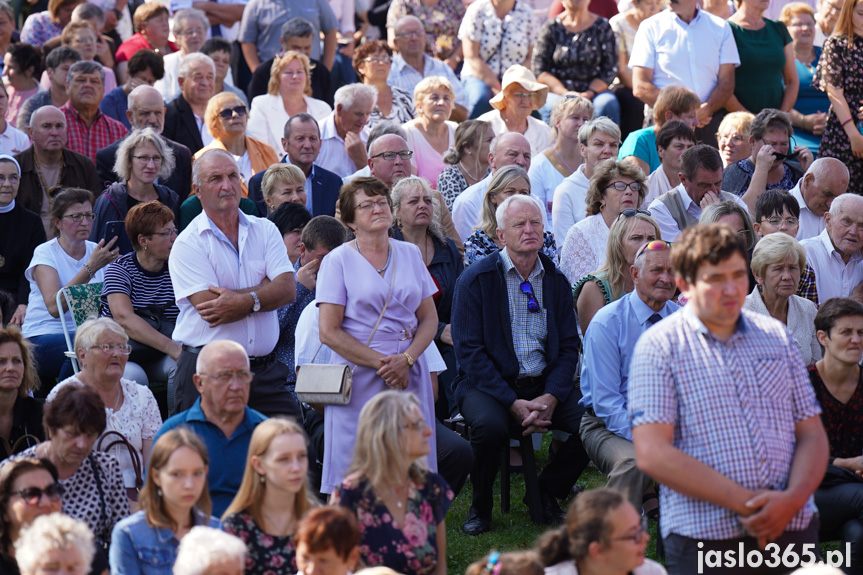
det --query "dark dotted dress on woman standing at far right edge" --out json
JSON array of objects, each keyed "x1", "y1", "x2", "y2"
[{"x1": 812, "y1": 34, "x2": 863, "y2": 194}]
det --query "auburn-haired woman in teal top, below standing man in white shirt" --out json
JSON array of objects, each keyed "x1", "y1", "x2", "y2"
[{"x1": 618, "y1": 86, "x2": 701, "y2": 176}]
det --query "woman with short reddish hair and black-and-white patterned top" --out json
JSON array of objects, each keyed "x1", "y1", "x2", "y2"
[{"x1": 354, "y1": 40, "x2": 417, "y2": 129}]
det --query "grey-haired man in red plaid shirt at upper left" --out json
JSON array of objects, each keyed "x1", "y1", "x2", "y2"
[{"x1": 60, "y1": 61, "x2": 129, "y2": 162}]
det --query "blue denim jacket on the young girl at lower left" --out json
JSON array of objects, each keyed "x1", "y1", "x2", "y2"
[{"x1": 108, "y1": 511, "x2": 222, "y2": 575}]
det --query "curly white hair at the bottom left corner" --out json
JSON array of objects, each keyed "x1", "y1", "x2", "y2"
[{"x1": 15, "y1": 512, "x2": 96, "y2": 574}]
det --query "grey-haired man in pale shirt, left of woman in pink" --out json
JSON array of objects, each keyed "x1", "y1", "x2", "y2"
[{"x1": 317, "y1": 84, "x2": 377, "y2": 178}]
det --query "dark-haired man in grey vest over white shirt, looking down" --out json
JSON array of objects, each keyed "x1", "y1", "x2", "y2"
[{"x1": 648, "y1": 144, "x2": 748, "y2": 242}]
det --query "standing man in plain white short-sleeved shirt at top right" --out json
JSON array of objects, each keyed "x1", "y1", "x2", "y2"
[{"x1": 629, "y1": 0, "x2": 740, "y2": 146}]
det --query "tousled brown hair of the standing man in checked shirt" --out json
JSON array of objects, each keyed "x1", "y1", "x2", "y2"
[{"x1": 671, "y1": 224, "x2": 747, "y2": 284}]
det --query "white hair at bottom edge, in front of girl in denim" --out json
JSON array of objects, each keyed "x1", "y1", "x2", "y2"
[{"x1": 174, "y1": 525, "x2": 246, "y2": 575}]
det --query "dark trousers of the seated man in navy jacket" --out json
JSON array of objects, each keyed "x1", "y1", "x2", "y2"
[{"x1": 460, "y1": 383, "x2": 589, "y2": 517}]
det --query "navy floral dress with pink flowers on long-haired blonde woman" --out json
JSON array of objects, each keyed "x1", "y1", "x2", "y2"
[{"x1": 333, "y1": 472, "x2": 455, "y2": 575}]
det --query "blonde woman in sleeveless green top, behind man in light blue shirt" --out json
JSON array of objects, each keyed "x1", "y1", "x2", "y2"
[{"x1": 572, "y1": 214, "x2": 660, "y2": 333}]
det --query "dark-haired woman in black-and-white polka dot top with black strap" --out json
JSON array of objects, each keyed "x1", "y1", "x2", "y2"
[{"x1": 14, "y1": 385, "x2": 129, "y2": 545}]
